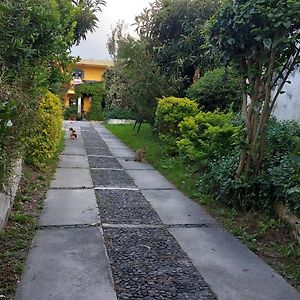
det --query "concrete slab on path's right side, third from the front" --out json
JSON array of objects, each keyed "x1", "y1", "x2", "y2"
[{"x1": 126, "y1": 170, "x2": 175, "y2": 190}]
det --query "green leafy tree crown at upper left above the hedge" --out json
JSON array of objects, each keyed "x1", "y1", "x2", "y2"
[{"x1": 0, "y1": 0, "x2": 104, "y2": 90}]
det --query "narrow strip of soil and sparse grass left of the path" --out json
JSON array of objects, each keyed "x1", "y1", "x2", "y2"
[{"x1": 0, "y1": 136, "x2": 64, "y2": 300}]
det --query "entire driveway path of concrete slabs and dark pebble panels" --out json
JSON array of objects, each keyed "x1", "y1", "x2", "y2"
[{"x1": 16, "y1": 122, "x2": 300, "y2": 300}]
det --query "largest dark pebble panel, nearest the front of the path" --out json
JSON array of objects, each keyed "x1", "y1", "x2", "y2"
[{"x1": 104, "y1": 228, "x2": 216, "y2": 300}]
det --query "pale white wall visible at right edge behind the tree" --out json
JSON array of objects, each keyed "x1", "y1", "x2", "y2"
[{"x1": 273, "y1": 68, "x2": 300, "y2": 122}]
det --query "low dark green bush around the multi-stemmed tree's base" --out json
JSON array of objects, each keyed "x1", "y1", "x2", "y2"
[{"x1": 198, "y1": 120, "x2": 300, "y2": 214}]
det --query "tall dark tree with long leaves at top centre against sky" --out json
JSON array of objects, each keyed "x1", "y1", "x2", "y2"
[{"x1": 136, "y1": 0, "x2": 220, "y2": 95}]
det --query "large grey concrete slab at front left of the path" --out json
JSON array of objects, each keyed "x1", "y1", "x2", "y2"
[{"x1": 16, "y1": 228, "x2": 117, "y2": 300}]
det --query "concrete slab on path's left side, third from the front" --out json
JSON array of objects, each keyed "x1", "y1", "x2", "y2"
[{"x1": 50, "y1": 168, "x2": 93, "y2": 188}]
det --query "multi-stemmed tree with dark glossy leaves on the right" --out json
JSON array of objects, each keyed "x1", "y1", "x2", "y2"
[{"x1": 207, "y1": 0, "x2": 300, "y2": 178}]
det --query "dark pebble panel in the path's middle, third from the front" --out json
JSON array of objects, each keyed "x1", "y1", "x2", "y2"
[{"x1": 91, "y1": 170, "x2": 136, "y2": 188}]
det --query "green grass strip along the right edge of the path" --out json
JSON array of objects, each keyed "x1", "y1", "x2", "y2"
[{"x1": 106, "y1": 124, "x2": 300, "y2": 291}]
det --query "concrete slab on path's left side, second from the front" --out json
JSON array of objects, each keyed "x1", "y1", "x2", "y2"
[{"x1": 39, "y1": 190, "x2": 100, "y2": 226}]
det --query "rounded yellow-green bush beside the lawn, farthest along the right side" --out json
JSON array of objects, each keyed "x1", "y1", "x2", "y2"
[{"x1": 155, "y1": 97, "x2": 198, "y2": 152}]
